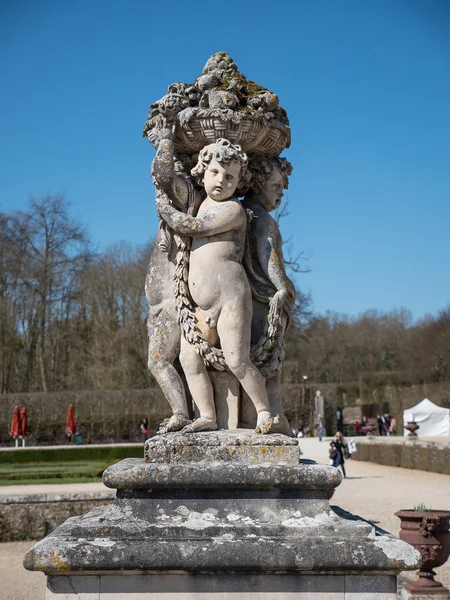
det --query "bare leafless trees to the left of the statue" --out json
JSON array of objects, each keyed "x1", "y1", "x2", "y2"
[{"x1": 0, "y1": 196, "x2": 151, "y2": 393}]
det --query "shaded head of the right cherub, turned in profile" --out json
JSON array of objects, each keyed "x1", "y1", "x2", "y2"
[{"x1": 248, "y1": 157, "x2": 292, "y2": 212}]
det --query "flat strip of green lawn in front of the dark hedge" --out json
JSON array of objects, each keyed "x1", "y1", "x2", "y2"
[{"x1": 0, "y1": 460, "x2": 111, "y2": 486}]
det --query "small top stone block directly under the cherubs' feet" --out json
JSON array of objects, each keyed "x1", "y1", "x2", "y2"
[{"x1": 144, "y1": 429, "x2": 300, "y2": 465}]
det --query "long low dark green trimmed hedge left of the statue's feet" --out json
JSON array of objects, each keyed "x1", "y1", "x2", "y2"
[{"x1": 0, "y1": 444, "x2": 144, "y2": 464}]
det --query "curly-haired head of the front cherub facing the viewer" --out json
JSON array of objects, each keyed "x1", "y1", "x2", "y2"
[{"x1": 191, "y1": 139, "x2": 247, "y2": 202}]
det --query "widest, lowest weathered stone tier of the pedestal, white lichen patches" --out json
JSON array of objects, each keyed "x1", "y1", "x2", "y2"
[{"x1": 24, "y1": 499, "x2": 417, "y2": 574}]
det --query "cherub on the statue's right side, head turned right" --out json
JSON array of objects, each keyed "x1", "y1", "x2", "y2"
[{"x1": 243, "y1": 157, "x2": 295, "y2": 435}]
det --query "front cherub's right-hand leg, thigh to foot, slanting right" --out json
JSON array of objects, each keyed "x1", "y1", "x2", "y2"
[{"x1": 217, "y1": 297, "x2": 272, "y2": 433}]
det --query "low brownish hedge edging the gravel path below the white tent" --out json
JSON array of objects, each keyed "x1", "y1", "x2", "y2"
[{"x1": 352, "y1": 438, "x2": 450, "y2": 475}]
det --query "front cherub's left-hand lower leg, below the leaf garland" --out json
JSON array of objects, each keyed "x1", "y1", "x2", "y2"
[{"x1": 180, "y1": 336, "x2": 217, "y2": 433}]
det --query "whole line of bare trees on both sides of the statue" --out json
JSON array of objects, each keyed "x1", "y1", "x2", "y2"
[{"x1": 0, "y1": 196, "x2": 450, "y2": 393}]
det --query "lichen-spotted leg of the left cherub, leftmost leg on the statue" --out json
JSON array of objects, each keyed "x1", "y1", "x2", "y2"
[{"x1": 147, "y1": 307, "x2": 190, "y2": 433}]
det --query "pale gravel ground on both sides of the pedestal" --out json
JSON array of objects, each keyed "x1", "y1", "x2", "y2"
[{"x1": 0, "y1": 438, "x2": 450, "y2": 600}]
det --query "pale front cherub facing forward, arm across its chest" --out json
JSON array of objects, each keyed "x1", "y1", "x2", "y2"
[{"x1": 153, "y1": 139, "x2": 273, "y2": 433}]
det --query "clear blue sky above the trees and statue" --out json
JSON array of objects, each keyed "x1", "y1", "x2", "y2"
[{"x1": 0, "y1": 0, "x2": 450, "y2": 318}]
